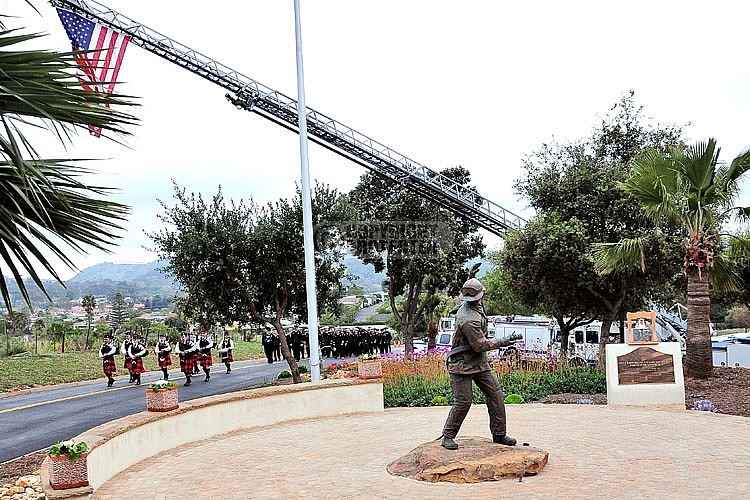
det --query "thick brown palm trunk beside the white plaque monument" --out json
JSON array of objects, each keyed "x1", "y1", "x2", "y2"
[{"x1": 685, "y1": 267, "x2": 713, "y2": 378}]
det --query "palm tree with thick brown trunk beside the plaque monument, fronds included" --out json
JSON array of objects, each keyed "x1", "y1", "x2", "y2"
[{"x1": 597, "y1": 138, "x2": 750, "y2": 378}]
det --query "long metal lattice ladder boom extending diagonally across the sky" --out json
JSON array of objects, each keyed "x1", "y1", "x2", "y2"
[{"x1": 50, "y1": 0, "x2": 525, "y2": 236}]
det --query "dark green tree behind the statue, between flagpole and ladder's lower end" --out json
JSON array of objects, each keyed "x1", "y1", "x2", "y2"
[{"x1": 344, "y1": 167, "x2": 484, "y2": 352}]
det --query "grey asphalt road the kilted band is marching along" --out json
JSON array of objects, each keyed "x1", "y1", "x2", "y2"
[{"x1": 0, "y1": 358, "x2": 346, "y2": 463}]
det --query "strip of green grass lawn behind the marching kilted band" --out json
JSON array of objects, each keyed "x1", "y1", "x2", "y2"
[{"x1": 0, "y1": 337, "x2": 265, "y2": 391}]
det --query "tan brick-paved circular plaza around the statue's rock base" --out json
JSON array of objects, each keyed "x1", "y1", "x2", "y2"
[{"x1": 92, "y1": 404, "x2": 750, "y2": 500}]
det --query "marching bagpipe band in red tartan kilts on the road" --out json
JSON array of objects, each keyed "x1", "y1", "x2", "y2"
[{"x1": 99, "y1": 332, "x2": 234, "y2": 387}]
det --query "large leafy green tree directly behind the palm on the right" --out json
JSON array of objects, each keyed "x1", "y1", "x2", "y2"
[{"x1": 500, "y1": 92, "x2": 682, "y2": 352}]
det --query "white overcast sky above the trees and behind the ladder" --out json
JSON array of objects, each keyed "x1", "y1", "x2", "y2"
[{"x1": 8, "y1": 0, "x2": 750, "y2": 279}]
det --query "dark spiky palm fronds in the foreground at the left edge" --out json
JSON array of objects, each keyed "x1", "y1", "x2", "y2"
[{"x1": 0, "y1": 13, "x2": 136, "y2": 310}]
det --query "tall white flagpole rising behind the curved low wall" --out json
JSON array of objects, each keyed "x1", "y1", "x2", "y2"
[{"x1": 294, "y1": 0, "x2": 320, "y2": 382}]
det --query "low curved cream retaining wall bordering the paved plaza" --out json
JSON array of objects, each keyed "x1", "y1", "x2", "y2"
[{"x1": 42, "y1": 379, "x2": 383, "y2": 500}]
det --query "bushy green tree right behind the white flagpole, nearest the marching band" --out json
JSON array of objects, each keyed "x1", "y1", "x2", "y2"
[{"x1": 149, "y1": 184, "x2": 347, "y2": 383}]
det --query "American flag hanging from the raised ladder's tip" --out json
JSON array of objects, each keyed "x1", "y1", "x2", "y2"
[{"x1": 57, "y1": 9, "x2": 130, "y2": 137}]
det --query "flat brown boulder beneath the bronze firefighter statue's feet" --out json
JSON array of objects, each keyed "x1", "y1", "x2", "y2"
[{"x1": 386, "y1": 437, "x2": 549, "y2": 483}]
